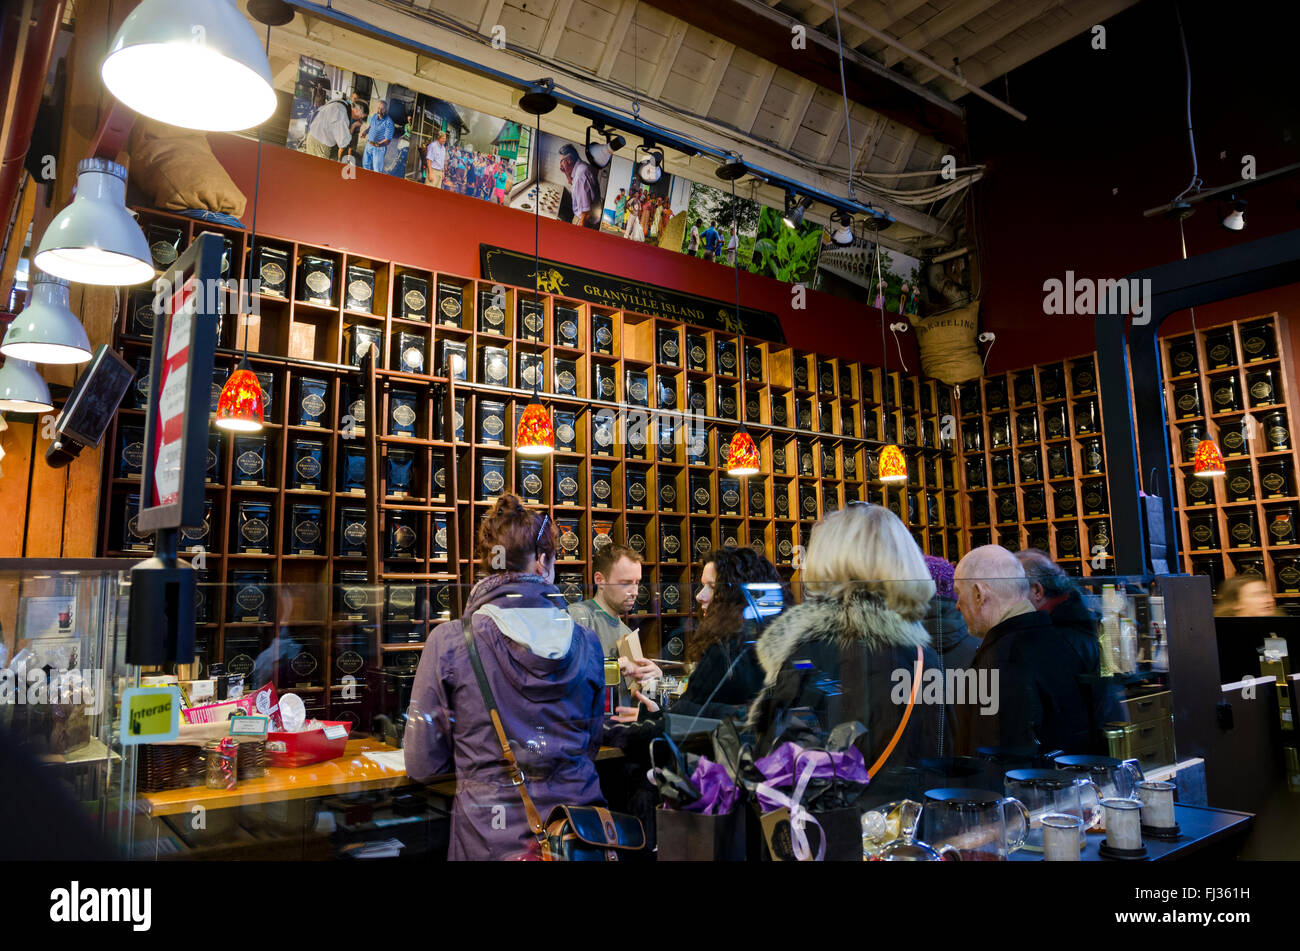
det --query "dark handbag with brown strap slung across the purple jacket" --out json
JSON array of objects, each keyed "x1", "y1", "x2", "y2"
[{"x1": 462, "y1": 615, "x2": 646, "y2": 861}]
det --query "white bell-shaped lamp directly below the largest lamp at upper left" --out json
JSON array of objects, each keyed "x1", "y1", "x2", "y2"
[{"x1": 33, "y1": 159, "x2": 153, "y2": 287}]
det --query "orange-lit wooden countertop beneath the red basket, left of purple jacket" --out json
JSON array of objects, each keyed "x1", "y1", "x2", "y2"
[{"x1": 139, "y1": 739, "x2": 623, "y2": 816}]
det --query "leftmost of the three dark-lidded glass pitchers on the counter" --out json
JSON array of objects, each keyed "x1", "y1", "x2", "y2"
[{"x1": 922, "y1": 789, "x2": 1030, "y2": 861}]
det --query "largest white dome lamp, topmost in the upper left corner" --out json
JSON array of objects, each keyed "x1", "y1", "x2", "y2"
[{"x1": 100, "y1": 0, "x2": 276, "y2": 133}]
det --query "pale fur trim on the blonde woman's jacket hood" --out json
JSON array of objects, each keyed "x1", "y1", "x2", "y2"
[{"x1": 754, "y1": 591, "x2": 930, "y2": 685}]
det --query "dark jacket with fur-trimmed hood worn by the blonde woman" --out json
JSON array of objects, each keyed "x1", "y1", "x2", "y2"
[{"x1": 748, "y1": 587, "x2": 941, "y2": 805}]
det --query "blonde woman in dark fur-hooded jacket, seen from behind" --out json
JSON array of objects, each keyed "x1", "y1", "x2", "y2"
[{"x1": 749, "y1": 503, "x2": 944, "y2": 805}]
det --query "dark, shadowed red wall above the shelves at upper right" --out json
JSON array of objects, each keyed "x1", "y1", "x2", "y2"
[{"x1": 970, "y1": 3, "x2": 1300, "y2": 370}]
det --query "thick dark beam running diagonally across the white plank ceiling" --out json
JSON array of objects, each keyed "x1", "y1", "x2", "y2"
[{"x1": 645, "y1": 0, "x2": 966, "y2": 144}]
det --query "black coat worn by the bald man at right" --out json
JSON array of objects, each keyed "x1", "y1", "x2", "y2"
[{"x1": 957, "y1": 611, "x2": 1091, "y2": 755}]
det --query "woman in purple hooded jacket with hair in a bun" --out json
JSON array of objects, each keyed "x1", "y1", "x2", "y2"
[{"x1": 403, "y1": 495, "x2": 605, "y2": 860}]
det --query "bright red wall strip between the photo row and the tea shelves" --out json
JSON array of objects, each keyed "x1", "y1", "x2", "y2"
[{"x1": 208, "y1": 135, "x2": 917, "y2": 369}]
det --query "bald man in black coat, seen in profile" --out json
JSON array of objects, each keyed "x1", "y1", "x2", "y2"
[{"x1": 953, "y1": 544, "x2": 1089, "y2": 756}]
